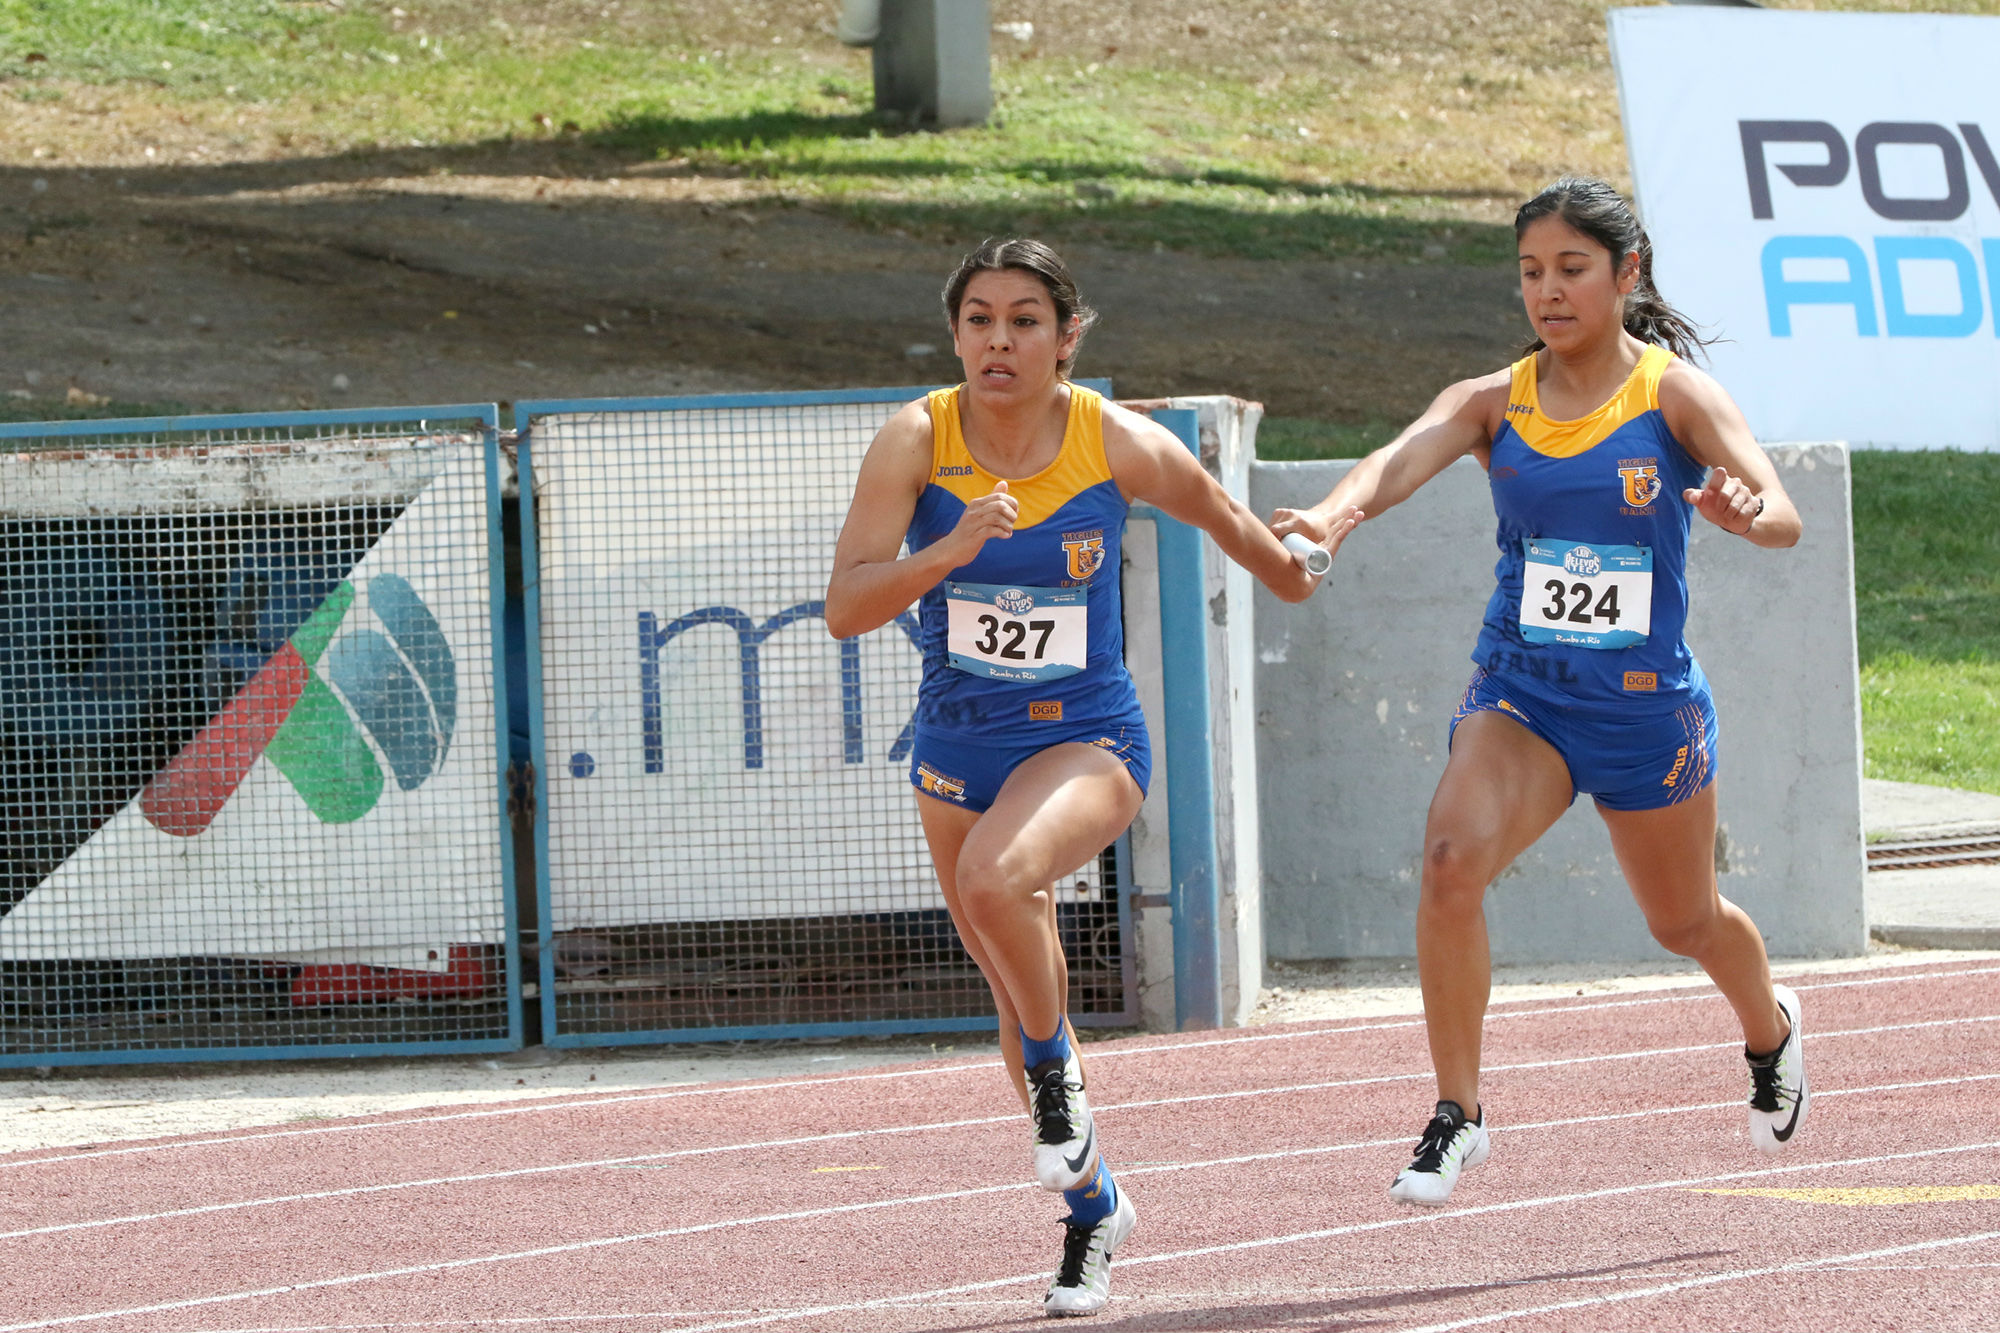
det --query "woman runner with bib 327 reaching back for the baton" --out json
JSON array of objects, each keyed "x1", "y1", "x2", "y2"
[{"x1": 826, "y1": 240, "x2": 1354, "y2": 1315}]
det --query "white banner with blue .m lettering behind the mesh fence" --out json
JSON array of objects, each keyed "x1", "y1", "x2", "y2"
[{"x1": 532, "y1": 400, "x2": 942, "y2": 933}]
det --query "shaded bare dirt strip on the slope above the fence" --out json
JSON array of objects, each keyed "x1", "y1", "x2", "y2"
[{"x1": 0, "y1": 144, "x2": 1526, "y2": 422}]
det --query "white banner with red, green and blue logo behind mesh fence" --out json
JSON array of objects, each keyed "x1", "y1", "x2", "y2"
[{"x1": 0, "y1": 442, "x2": 504, "y2": 971}]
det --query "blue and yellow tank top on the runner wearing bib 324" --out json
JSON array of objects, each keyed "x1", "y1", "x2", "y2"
[{"x1": 1472, "y1": 346, "x2": 1708, "y2": 713}]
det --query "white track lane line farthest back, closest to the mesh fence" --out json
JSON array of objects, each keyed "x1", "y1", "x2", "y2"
[{"x1": 0, "y1": 967, "x2": 2000, "y2": 1171}]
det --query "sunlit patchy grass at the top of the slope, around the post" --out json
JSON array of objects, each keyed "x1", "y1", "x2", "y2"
[{"x1": 0, "y1": 0, "x2": 1622, "y2": 264}]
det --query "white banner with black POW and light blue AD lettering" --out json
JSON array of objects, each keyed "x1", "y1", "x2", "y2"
[{"x1": 1610, "y1": 6, "x2": 2000, "y2": 450}]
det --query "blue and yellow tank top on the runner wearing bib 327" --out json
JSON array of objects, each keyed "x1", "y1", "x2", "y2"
[{"x1": 908, "y1": 384, "x2": 1138, "y2": 741}]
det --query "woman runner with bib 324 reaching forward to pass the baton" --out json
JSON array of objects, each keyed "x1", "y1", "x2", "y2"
[{"x1": 1272, "y1": 178, "x2": 1810, "y2": 1205}]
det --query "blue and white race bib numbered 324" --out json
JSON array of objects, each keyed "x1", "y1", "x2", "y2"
[{"x1": 1520, "y1": 536, "x2": 1652, "y2": 648}]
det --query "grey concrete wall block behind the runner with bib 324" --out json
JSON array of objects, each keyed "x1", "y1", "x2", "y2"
[{"x1": 1250, "y1": 444, "x2": 1866, "y2": 963}]
